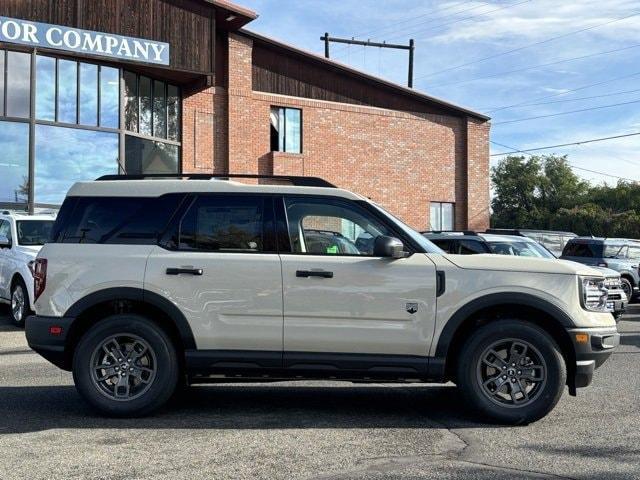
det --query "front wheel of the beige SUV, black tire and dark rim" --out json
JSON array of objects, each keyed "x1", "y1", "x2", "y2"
[{"x1": 457, "y1": 320, "x2": 567, "y2": 425}]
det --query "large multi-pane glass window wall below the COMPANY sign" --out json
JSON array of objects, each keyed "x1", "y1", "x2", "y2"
[{"x1": 0, "y1": 50, "x2": 181, "y2": 207}]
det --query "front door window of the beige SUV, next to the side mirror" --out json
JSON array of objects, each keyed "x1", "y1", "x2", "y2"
[{"x1": 285, "y1": 198, "x2": 393, "y2": 256}]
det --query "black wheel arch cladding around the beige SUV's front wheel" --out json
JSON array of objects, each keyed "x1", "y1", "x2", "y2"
[{"x1": 433, "y1": 292, "x2": 575, "y2": 390}]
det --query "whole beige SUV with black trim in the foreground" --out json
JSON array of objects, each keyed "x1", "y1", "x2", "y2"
[{"x1": 26, "y1": 176, "x2": 620, "y2": 424}]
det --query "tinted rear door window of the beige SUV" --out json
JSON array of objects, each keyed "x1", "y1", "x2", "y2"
[{"x1": 171, "y1": 195, "x2": 265, "y2": 252}]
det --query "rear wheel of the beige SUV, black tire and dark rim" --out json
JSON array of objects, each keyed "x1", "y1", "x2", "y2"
[{"x1": 73, "y1": 314, "x2": 179, "y2": 417}]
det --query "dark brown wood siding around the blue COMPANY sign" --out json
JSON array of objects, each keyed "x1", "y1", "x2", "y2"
[{"x1": 0, "y1": 0, "x2": 215, "y2": 74}]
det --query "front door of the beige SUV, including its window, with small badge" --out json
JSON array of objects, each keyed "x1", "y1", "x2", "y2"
[{"x1": 281, "y1": 197, "x2": 436, "y2": 368}]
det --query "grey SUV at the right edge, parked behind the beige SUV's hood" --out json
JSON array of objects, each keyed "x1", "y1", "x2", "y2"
[{"x1": 560, "y1": 237, "x2": 640, "y2": 301}]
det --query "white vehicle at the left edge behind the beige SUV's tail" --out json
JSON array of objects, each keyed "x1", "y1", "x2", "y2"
[{"x1": 0, "y1": 210, "x2": 54, "y2": 327}]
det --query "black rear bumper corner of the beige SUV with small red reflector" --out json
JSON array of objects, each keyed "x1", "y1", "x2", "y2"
[{"x1": 25, "y1": 315, "x2": 75, "y2": 370}]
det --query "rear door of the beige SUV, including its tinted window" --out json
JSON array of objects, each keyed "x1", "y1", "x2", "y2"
[{"x1": 145, "y1": 194, "x2": 283, "y2": 366}]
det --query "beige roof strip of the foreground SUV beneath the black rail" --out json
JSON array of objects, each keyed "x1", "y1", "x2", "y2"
[{"x1": 67, "y1": 179, "x2": 364, "y2": 200}]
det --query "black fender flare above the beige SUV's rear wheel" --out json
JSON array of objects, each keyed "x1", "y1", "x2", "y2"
[{"x1": 64, "y1": 287, "x2": 196, "y2": 350}]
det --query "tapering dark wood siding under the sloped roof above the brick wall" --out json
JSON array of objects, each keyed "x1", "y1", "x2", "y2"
[{"x1": 252, "y1": 40, "x2": 462, "y2": 116}]
